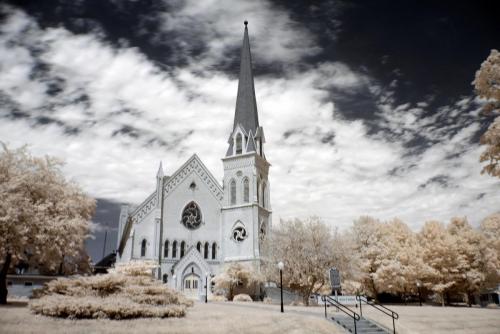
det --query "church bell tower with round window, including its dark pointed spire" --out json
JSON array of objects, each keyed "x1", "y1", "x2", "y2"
[{"x1": 222, "y1": 21, "x2": 272, "y2": 268}]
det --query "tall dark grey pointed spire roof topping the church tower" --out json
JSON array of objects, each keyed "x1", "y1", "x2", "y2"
[{"x1": 233, "y1": 21, "x2": 259, "y2": 133}]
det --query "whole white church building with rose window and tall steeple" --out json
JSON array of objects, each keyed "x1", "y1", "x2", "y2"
[{"x1": 117, "y1": 22, "x2": 272, "y2": 298}]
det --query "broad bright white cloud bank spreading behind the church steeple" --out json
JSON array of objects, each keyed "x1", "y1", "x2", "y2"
[{"x1": 0, "y1": 1, "x2": 500, "y2": 243}]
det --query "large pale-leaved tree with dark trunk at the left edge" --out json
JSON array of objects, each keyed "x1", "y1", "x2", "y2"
[{"x1": 0, "y1": 144, "x2": 95, "y2": 304}]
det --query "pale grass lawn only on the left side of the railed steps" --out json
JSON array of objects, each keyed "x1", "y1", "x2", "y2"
[{"x1": 0, "y1": 301, "x2": 342, "y2": 334}]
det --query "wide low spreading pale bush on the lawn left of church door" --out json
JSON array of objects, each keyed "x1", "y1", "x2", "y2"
[{"x1": 30, "y1": 262, "x2": 193, "y2": 319}]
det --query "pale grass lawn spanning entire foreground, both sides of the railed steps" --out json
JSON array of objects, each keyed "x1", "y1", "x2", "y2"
[{"x1": 0, "y1": 301, "x2": 500, "y2": 334}]
